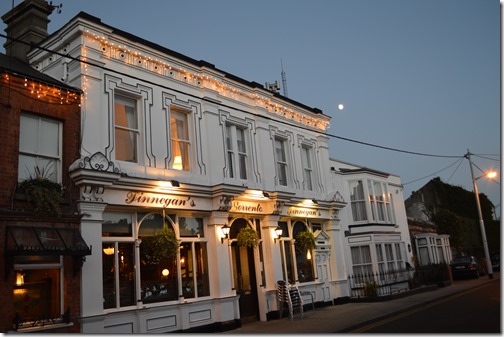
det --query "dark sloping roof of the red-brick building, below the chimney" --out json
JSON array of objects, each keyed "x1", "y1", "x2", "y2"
[{"x1": 0, "y1": 53, "x2": 81, "y2": 92}]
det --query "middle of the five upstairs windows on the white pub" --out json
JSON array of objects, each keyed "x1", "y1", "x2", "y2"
[{"x1": 226, "y1": 124, "x2": 247, "y2": 179}]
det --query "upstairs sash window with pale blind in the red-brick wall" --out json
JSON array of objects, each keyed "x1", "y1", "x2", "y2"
[{"x1": 18, "y1": 114, "x2": 63, "y2": 182}]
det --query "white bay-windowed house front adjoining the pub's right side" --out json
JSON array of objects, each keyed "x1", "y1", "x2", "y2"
[{"x1": 330, "y1": 159, "x2": 413, "y2": 296}]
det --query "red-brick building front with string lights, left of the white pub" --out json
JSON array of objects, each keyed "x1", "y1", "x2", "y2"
[{"x1": 0, "y1": 1, "x2": 86, "y2": 333}]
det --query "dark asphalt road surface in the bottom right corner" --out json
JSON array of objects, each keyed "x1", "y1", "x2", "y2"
[{"x1": 351, "y1": 282, "x2": 501, "y2": 333}]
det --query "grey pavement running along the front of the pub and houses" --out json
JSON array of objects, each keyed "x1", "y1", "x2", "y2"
[{"x1": 224, "y1": 272, "x2": 500, "y2": 334}]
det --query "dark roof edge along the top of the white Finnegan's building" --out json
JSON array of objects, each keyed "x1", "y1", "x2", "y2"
[{"x1": 46, "y1": 12, "x2": 323, "y2": 114}]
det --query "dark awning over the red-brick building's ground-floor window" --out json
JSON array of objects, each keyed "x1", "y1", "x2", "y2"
[{"x1": 5, "y1": 225, "x2": 91, "y2": 257}]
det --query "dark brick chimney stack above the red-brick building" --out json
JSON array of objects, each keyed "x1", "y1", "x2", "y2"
[{"x1": 2, "y1": 0, "x2": 54, "y2": 62}]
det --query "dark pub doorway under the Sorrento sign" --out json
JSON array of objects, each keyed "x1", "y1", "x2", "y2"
[{"x1": 230, "y1": 219, "x2": 259, "y2": 323}]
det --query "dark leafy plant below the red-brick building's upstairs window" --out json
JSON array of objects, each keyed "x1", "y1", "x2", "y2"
[{"x1": 18, "y1": 166, "x2": 63, "y2": 217}]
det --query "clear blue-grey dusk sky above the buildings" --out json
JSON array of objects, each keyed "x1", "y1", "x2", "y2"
[{"x1": 0, "y1": 0, "x2": 502, "y2": 214}]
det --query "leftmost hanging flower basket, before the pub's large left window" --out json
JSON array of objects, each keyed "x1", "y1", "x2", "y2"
[{"x1": 140, "y1": 225, "x2": 180, "y2": 264}]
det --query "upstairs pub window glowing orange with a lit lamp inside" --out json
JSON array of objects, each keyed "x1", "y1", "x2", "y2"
[{"x1": 170, "y1": 108, "x2": 190, "y2": 171}]
